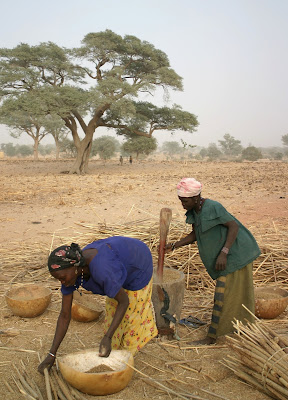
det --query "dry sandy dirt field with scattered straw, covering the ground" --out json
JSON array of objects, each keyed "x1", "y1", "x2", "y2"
[{"x1": 0, "y1": 160, "x2": 288, "y2": 400}]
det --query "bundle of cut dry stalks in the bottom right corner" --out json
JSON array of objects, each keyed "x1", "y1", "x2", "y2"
[{"x1": 224, "y1": 321, "x2": 288, "y2": 400}]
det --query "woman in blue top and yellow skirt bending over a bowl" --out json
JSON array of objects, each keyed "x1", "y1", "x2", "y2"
[{"x1": 38, "y1": 236, "x2": 158, "y2": 373}]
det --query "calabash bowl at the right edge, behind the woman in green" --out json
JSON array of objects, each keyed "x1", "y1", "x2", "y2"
[{"x1": 255, "y1": 287, "x2": 288, "y2": 319}]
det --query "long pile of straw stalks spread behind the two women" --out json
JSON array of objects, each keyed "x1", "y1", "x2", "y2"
[{"x1": 0, "y1": 218, "x2": 288, "y2": 296}]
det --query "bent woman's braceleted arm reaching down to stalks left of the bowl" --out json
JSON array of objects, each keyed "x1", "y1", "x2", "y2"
[{"x1": 38, "y1": 293, "x2": 73, "y2": 374}]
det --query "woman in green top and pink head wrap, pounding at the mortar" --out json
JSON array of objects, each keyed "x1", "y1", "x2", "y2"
[{"x1": 166, "y1": 178, "x2": 260, "y2": 344}]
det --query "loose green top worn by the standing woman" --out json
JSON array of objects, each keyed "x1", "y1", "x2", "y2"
[{"x1": 185, "y1": 199, "x2": 261, "y2": 279}]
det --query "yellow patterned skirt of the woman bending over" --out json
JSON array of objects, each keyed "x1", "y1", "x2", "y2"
[{"x1": 104, "y1": 279, "x2": 158, "y2": 354}]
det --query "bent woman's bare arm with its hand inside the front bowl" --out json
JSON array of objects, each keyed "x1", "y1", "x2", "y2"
[{"x1": 99, "y1": 288, "x2": 129, "y2": 357}]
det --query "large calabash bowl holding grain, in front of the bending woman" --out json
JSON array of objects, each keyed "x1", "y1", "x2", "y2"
[{"x1": 57, "y1": 349, "x2": 134, "y2": 396}]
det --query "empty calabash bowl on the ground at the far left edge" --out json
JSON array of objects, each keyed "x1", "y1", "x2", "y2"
[{"x1": 5, "y1": 285, "x2": 52, "y2": 318}]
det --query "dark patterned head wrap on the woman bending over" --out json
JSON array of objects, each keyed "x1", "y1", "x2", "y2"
[{"x1": 48, "y1": 243, "x2": 86, "y2": 272}]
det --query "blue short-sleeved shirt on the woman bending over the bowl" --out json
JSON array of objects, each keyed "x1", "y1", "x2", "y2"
[{"x1": 61, "y1": 236, "x2": 153, "y2": 298}]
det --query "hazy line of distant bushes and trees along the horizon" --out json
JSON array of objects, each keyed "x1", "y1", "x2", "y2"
[{"x1": 1, "y1": 133, "x2": 288, "y2": 161}]
